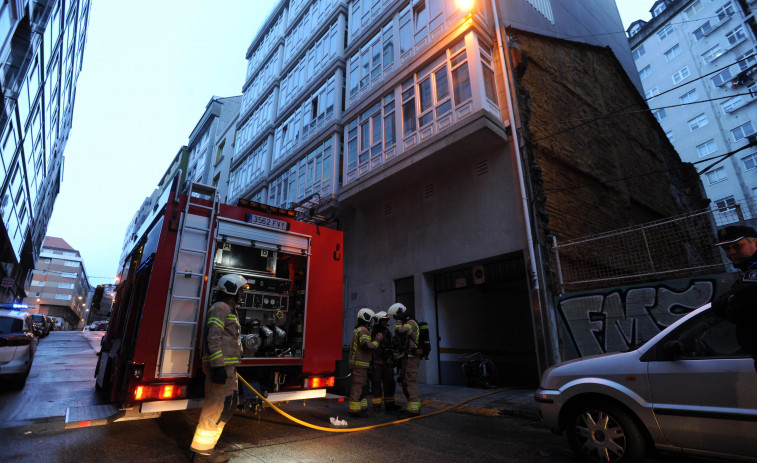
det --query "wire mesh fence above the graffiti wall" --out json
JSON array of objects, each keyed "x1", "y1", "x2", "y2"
[{"x1": 552, "y1": 198, "x2": 757, "y2": 294}]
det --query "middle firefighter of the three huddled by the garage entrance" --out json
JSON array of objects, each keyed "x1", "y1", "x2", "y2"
[{"x1": 369, "y1": 311, "x2": 400, "y2": 412}]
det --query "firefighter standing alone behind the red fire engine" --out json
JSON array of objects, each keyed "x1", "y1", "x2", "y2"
[{"x1": 190, "y1": 274, "x2": 249, "y2": 462}]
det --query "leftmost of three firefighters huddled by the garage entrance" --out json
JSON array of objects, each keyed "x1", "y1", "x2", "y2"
[{"x1": 350, "y1": 309, "x2": 383, "y2": 418}]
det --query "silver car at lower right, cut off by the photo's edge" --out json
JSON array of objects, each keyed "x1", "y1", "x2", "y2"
[{"x1": 535, "y1": 304, "x2": 757, "y2": 463}]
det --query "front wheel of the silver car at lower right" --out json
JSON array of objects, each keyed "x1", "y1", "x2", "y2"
[{"x1": 567, "y1": 401, "x2": 644, "y2": 463}]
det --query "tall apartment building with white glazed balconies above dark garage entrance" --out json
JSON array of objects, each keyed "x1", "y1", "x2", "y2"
[{"x1": 228, "y1": 0, "x2": 704, "y2": 385}]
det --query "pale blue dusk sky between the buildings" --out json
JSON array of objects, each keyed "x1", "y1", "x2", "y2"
[{"x1": 48, "y1": 0, "x2": 653, "y2": 285}]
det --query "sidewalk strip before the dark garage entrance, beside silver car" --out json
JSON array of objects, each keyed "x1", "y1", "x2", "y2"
[{"x1": 414, "y1": 384, "x2": 540, "y2": 421}]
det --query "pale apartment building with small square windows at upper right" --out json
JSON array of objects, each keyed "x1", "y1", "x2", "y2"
[{"x1": 627, "y1": 0, "x2": 757, "y2": 224}]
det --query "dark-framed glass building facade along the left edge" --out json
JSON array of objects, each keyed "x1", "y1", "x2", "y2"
[{"x1": 0, "y1": 0, "x2": 90, "y2": 302}]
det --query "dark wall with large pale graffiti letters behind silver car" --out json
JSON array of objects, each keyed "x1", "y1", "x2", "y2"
[{"x1": 557, "y1": 278, "x2": 717, "y2": 357}]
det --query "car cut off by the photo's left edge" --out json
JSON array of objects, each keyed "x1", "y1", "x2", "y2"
[{"x1": 0, "y1": 309, "x2": 39, "y2": 388}]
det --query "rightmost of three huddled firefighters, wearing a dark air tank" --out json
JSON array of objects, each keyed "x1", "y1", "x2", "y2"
[{"x1": 387, "y1": 302, "x2": 421, "y2": 417}]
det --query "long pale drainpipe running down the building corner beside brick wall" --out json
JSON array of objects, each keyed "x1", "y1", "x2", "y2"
[{"x1": 491, "y1": 0, "x2": 558, "y2": 376}]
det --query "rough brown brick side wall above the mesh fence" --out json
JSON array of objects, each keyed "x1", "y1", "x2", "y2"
[{"x1": 508, "y1": 30, "x2": 708, "y2": 294}]
